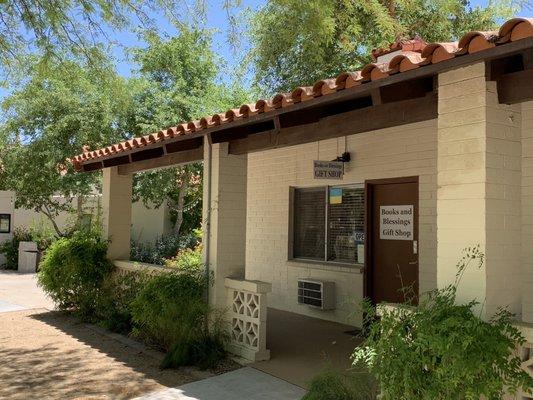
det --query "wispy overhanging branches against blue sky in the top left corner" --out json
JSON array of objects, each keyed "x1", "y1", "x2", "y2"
[{"x1": 0, "y1": 0, "x2": 182, "y2": 73}]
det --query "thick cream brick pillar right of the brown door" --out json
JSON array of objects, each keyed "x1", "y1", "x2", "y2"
[{"x1": 437, "y1": 63, "x2": 521, "y2": 315}]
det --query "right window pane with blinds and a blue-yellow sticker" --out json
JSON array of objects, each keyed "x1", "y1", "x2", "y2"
[{"x1": 327, "y1": 186, "x2": 365, "y2": 264}]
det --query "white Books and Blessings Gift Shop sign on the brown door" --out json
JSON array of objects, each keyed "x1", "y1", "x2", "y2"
[{"x1": 379, "y1": 205, "x2": 414, "y2": 240}]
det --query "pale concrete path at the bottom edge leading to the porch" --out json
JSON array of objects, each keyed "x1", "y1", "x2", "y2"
[{"x1": 136, "y1": 367, "x2": 305, "y2": 400}]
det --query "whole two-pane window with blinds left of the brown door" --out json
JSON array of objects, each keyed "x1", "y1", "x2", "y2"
[{"x1": 292, "y1": 185, "x2": 365, "y2": 264}]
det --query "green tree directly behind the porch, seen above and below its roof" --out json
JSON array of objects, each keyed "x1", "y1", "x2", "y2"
[{"x1": 131, "y1": 30, "x2": 251, "y2": 233}]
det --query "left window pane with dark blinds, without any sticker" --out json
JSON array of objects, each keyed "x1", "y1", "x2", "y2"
[{"x1": 293, "y1": 187, "x2": 326, "y2": 260}]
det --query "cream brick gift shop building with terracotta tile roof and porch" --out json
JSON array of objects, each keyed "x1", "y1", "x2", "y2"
[{"x1": 69, "y1": 18, "x2": 533, "y2": 392}]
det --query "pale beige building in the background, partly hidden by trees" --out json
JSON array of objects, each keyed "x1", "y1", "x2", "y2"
[{"x1": 0, "y1": 190, "x2": 172, "y2": 265}]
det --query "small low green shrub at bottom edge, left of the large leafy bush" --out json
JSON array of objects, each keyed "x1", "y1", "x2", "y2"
[{"x1": 302, "y1": 369, "x2": 378, "y2": 400}]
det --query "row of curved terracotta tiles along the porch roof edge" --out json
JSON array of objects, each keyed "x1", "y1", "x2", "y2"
[{"x1": 68, "y1": 18, "x2": 533, "y2": 170}]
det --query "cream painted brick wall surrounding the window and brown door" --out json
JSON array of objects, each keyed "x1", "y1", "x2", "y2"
[{"x1": 246, "y1": 120, "x2": 437, "y2": 325}]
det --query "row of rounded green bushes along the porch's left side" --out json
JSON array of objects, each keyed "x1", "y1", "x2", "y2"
[{"x1": 38, "y1": 233, "x2": 228, "y2": 369}]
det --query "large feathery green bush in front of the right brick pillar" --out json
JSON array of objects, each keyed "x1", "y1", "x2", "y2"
[{"x1": 353, "y1": 248, "x2": 533, "y2": 400}]
